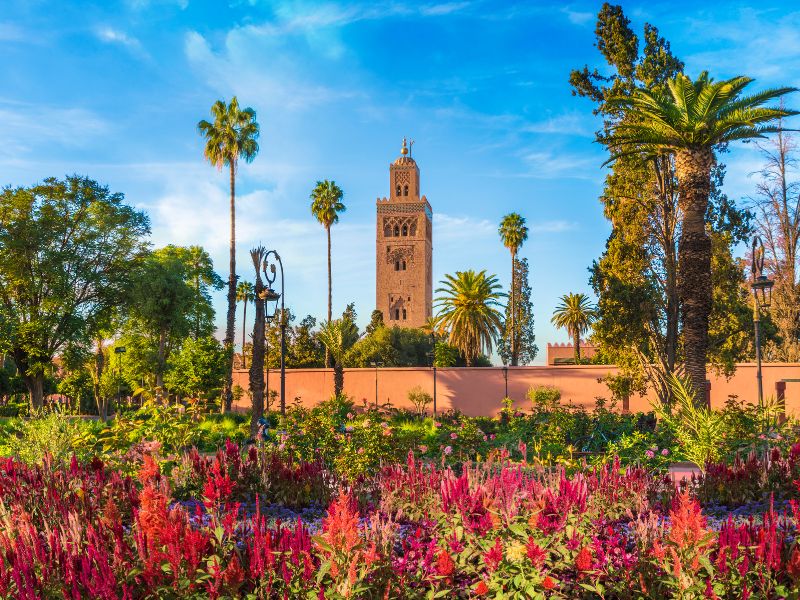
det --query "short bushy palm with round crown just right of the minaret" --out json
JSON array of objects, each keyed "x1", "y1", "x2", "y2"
[{"x1": 436, "y1": 270, "x2": 505, "y2": 366}]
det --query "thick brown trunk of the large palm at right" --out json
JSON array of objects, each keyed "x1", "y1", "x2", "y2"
[{"x1": 675, "y1": 148, "x2": 714, "y2": 404}]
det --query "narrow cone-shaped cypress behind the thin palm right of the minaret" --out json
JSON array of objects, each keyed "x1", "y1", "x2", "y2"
[{"x1": 497, "y1": 258, "x2": 539, "y2": 366}]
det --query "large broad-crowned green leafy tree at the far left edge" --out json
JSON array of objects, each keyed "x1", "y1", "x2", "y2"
[{"x1": 0, "y1": 175, "x2": 149, "y2": 409}]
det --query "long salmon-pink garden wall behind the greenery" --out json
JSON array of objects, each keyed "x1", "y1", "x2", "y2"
[{"x1": 234, "y1": 363, "x2": 800, "y2": 417}]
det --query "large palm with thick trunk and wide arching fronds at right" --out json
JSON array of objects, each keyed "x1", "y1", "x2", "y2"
[{"x1": 609, "y1": 72, "x2": 797, "y2": 398}]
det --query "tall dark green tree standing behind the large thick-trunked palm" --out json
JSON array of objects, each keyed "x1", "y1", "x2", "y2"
[{"x1": 570, "y1": 3, "x2": 750, "y2": 402}]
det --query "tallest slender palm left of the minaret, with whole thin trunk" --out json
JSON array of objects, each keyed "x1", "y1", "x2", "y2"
[{"x1": 197, "y1": 96, "x2": 259, "y2": 411}]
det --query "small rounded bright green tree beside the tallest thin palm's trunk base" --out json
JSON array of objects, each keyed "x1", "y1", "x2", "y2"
[{"x1": 164, "y1": 336, "x2": 225, "y2": 398}]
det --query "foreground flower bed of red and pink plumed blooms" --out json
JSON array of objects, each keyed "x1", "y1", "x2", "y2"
[{"x1": 0, "y1": 444, "x2": 800, "y2": 599}]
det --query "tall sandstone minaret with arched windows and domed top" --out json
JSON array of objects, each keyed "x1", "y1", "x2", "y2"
[{"x1": 375, "y1": 138, "x2": 433, "y2": 327}]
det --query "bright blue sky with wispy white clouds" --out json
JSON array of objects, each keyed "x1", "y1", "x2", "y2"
[{"x1": 0, "y1": 0, "x2": 800, "y2": 360}]
